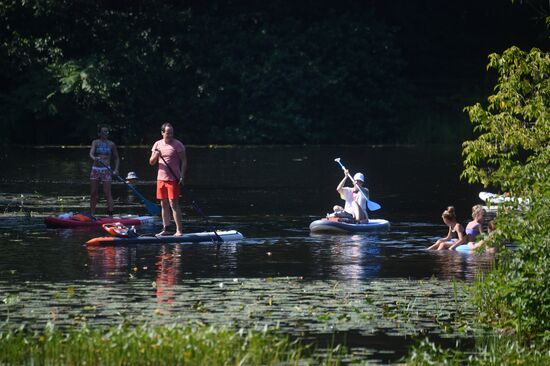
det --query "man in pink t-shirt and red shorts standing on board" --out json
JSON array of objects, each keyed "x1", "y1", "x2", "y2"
[{"x1": 149, "y1": 123, "x2": 187, "y2": 236}]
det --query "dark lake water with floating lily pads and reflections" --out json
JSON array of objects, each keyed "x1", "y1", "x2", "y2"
[{"x1": 0, "y1": 146, "x2": 494, "y2": 362}]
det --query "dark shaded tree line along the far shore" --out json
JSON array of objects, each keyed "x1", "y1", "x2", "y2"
[{"x1": 0, "y1": 0, "x2": 544, "y2": 144}]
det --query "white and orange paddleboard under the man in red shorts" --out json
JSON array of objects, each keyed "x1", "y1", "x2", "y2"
[{"x1": 86, "y1": 230, "x2": 244, "y2": 246}]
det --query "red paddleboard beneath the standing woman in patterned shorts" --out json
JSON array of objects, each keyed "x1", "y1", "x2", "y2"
[{"x1": 44, "y1": 214, "x2": 154, "y2": 228}]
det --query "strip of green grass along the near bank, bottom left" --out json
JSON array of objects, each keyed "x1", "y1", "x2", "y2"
[{"x1": 0, "y1": 325, "x2": 340, "y2": 365}]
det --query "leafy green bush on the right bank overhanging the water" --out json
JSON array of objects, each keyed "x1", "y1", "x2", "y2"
[{"x1": 463, "y1": 47, "x2": 550, "y2": 344}]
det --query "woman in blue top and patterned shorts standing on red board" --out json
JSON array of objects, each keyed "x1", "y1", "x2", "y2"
[{"x1": 90, "y1": 126, "x2": 120, "y2": 216}]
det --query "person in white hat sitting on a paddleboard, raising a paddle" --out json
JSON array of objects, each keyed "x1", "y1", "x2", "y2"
[{"x1": 333, "y1": 169, "x2": 369, "y2": 224}]
